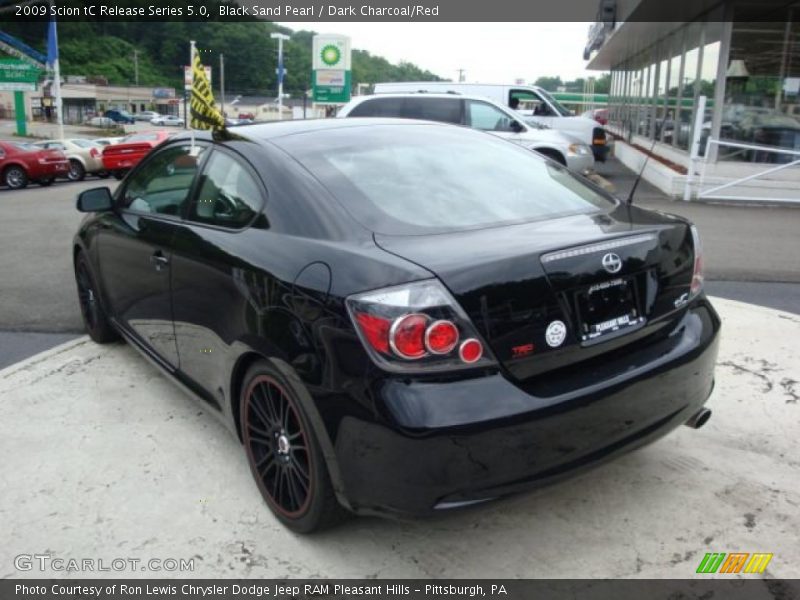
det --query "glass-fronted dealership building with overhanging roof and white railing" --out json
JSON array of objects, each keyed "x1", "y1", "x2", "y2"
[{"x1": 584, "y1": 0, "x2": 800, "y2": 202}]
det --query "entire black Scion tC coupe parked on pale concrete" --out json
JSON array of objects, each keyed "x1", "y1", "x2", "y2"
[{"x1": 73, "y1": 119, "x2": 720, "y2": 532}]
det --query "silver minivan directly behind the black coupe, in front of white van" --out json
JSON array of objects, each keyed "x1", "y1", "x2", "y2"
[{"x1": 336, "y1": 93, "x2": 594, "y2": 173}]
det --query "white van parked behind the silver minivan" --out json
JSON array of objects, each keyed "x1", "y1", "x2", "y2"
[{"x1": 375, "y1": 81, "x2": 609, "y2": 162}]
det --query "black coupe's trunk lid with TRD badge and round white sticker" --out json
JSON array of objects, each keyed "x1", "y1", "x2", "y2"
[{"x1": 375, "y1": 205, "x2": 694, "y2": 380}]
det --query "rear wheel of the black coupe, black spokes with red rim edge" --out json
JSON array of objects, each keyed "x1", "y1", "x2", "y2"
[{"x1": 239, "y1": 360, "x2": 349, "y2": 533}]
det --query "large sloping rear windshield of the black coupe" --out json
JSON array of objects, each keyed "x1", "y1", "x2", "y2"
[{"x1": 276, "y1": 124, "x2": 613, "y2": 235}]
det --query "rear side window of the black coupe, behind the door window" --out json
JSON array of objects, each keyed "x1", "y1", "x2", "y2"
[{"x1": 188, "y1": 152, "x2": 262, "y2": 229}]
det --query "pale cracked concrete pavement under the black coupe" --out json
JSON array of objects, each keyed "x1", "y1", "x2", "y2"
[{"x1": 0, "y1": 299, "x2": 800, "y2": 578}]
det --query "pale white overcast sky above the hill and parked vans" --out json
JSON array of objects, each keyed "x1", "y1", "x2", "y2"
[{"x1": 280, "y1": 21, "x2": 598, "y2": 83}]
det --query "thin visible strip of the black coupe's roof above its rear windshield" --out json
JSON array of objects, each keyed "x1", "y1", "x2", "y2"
[{"x1": 173, "y1": 117, "x2": 444, "y2": 141}]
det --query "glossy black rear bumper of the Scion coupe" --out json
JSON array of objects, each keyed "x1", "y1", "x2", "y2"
[{"x1": 334, "y1": 300, "x2": 720, "y2": 514}]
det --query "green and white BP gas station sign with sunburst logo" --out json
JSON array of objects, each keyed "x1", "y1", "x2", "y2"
[{"x1": 311, "y1": 34, "x2": 352, "y2": 104}]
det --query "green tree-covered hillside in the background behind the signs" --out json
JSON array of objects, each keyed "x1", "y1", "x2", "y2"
[{"x1": 2, "y1": 21, "x2": 440, "y2": 96}]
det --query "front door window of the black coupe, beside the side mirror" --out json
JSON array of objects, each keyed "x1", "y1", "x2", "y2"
[{"x1": 121, "y1": 144, "x2": 204, "y2": 215}]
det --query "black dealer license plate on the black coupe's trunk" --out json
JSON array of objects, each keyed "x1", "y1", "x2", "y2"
[{"x1": 576, "y1": 277, "x2": 644, "y2": 341}]
